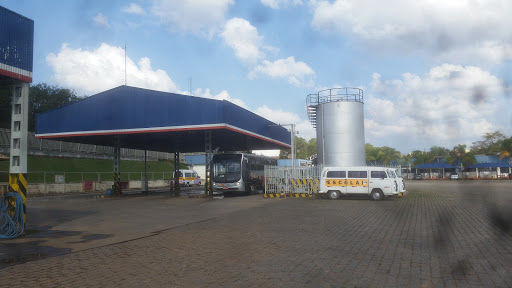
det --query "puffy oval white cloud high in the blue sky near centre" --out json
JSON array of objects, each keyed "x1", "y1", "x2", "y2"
[{"x1": 221, "y1": 18, "x2": 265, "y2": 64}]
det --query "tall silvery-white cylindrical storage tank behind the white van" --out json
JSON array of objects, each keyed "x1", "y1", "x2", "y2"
[{"x1": 308, "y1": 88, "x2": 366, "y2": 166}]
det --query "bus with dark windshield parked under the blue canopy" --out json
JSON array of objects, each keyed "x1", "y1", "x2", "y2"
[{"x1": 211, "y1": 153, "x2": 277, "y2": 194}]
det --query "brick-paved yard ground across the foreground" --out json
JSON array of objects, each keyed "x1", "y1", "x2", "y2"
[{"x1": 0, "y1": 181, "x2": 512, "y2": 287}]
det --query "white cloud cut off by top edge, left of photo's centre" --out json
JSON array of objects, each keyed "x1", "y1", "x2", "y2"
[{"x1": 151, "y1": 0, "x2": 234, "y2": 37}]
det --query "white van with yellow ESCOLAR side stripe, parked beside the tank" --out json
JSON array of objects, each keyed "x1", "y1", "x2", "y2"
[{"x1": 318, "y1": 166, "x2": 405, "y2": 200}]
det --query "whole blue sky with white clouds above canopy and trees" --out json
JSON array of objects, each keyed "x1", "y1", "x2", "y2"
[{"x1": 0, "y1": 0, "x2": 512, "y2": 153}]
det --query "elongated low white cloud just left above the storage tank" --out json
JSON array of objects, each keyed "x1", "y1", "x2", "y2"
[{"x1": 249, "y1": 56, "x2": 315, "y2": 86}]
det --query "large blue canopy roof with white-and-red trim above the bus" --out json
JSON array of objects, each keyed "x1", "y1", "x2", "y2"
[{"x1": 36, "y1": 86, "x2": 291, "y2": 152}]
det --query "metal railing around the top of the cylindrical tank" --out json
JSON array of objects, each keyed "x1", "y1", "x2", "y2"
[{"x1": 307, "y1": 87, "x2": 364, "y2": 106}]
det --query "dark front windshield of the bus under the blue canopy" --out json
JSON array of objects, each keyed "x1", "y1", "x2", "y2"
[{"x1": 212, "y1": 154, "x2": 242, "y2": 183}]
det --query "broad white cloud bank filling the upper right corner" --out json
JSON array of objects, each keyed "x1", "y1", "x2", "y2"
[{"x1": 311, "y1": 0, "x2": 512, "y2": 65}]
